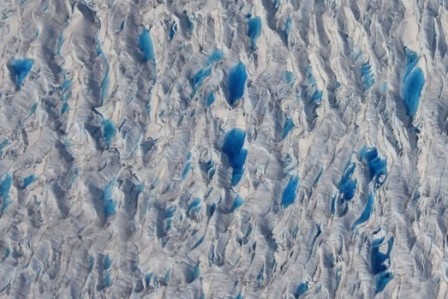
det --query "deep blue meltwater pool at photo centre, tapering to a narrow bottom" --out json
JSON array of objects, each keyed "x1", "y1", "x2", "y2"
[{"x1": 222, "y1": 128, "x2": 247, "y2": 186}]
